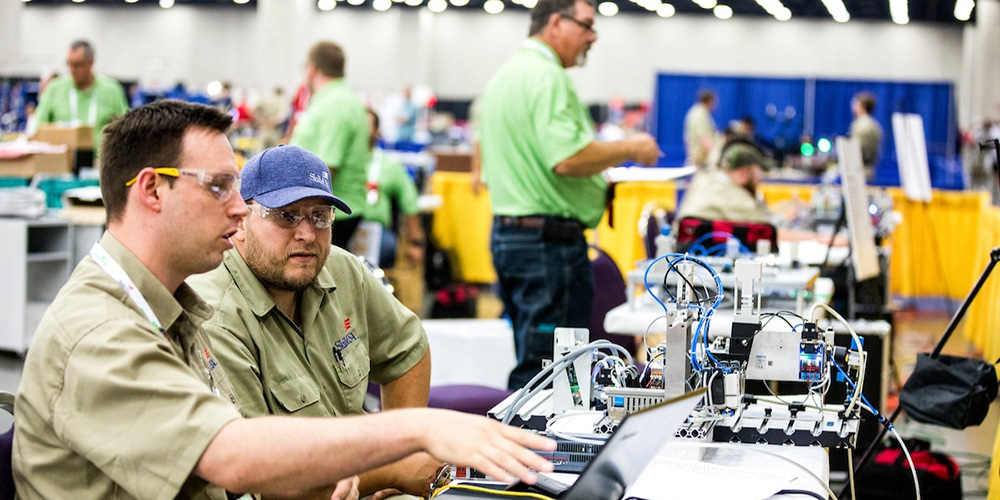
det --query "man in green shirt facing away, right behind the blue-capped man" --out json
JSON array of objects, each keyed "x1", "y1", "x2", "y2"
[{"x1": 289, "y1": 42, "x2": 368, "y2": 248}]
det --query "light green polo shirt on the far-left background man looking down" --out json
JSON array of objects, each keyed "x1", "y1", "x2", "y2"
[{"x1": 35, "y1": 75, "x2": 129, "y2": 152}]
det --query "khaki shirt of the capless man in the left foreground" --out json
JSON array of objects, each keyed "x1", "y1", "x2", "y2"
[{"x1": 13, "y1": 234, "x2": 240, "y2": 500}]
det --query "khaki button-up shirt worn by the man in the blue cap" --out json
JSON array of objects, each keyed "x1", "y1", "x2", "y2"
[{"x1": 189, "y1": 247, "x2": 427, "y2": 417}]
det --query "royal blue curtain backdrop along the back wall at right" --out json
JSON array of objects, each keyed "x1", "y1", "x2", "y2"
[{"x1": 652, "y1": 73, "x2": 962, "y2": 189}]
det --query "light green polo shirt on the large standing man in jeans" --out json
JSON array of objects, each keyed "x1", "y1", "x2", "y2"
[{"x1": 479, "y1": 38, "x2": 607, "y2": 227}]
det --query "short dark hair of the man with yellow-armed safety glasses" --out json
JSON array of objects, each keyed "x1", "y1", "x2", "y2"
[{"x1": 101, "y1": 100, "x2": 233, "y2": 222}]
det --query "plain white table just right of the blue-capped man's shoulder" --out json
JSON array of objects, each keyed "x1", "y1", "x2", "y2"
[{"x1": 422, "y1": 319, "x2": 517, "y2": 389}]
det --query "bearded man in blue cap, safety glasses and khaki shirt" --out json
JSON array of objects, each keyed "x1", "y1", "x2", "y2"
[{"x1": 190, "y1": 146, "x2": 441, "y2": 496}]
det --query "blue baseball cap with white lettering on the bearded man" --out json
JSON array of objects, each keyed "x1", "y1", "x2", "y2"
[{"x1": 240, "y1": 144, "x2": 351, "y2": 214}]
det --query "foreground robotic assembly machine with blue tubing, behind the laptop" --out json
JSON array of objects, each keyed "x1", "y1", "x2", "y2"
[{"x1": 490, "y1": 254, "x2": 868, "y2": 472}]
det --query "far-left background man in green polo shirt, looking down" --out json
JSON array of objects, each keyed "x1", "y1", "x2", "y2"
[{"x1": 35, "y1": 40, "x2": 128, "y2": 155}]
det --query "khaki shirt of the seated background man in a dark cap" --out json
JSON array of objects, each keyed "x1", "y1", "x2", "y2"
[{"x1": 677, "y1": 169, "x2": 771, "y2": 222}]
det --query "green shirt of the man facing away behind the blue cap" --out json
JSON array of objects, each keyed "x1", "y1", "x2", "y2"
[{"x1": 288, "y1": 78, "x2": 368, "y2": 219}]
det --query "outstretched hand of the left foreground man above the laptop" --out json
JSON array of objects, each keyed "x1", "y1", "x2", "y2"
[{"x1": 424, "y1": 412, "x2": 556, "y2": 484}]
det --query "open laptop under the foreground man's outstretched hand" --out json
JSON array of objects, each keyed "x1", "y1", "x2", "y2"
[{"x1": 442, "y1": 388, "x2": 706, "y2": 500}]
